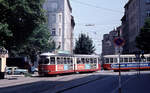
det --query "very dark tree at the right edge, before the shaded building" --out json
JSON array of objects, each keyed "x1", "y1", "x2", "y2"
[{"x1": 136, "y1": 19, "x2": 150, "y2": 53}]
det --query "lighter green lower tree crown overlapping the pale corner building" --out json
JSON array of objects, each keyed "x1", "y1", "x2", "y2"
[{"x1": 20, "y1": 24, "x2": 55, "y2": 55}]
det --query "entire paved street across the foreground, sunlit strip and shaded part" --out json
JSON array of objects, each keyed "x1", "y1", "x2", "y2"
[{"x1": 0, "y1": 71, "x2": 150, "y2": 93}]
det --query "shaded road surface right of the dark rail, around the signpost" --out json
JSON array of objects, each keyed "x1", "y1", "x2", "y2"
[{"x1": 61, "y1": 73, "x2": 150, "y2": 93}]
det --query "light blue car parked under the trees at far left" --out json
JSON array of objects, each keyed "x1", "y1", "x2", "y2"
[{"x1": 6, "y1": 67, "x2": 28, "y2": 75}]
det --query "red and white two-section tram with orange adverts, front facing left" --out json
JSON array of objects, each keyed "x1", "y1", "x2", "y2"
[{"x1": 38, "y1": 53, "x2": 101, "y2": 76}]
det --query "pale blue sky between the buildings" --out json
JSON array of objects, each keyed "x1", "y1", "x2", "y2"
[{"x1": 70, "y1": 0, "x2": 128, "y2": 54}]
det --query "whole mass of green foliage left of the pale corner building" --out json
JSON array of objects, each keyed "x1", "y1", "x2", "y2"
[{"x1": 0, "y1": 0, "x2": 54, "y2": 56}]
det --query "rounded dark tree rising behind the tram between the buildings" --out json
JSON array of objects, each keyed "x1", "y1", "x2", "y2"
[{"x1": 74, "y1": 34, "x2": 95, "y2": 54}]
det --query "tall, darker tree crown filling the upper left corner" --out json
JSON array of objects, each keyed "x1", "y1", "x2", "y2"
[{"x1": 0, "y1": 0, "x2": 46, "y2": 54}]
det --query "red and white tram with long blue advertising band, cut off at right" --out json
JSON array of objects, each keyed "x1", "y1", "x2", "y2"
[{"x1": 103, "y1": 54, "x2": 150, "y2": 71}]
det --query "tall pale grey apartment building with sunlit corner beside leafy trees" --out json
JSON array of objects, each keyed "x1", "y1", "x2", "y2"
[{"x1": 43, "y1": 0, "x2": 75, "y2": 53}]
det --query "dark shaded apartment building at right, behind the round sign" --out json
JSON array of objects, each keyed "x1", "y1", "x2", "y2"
[{"x1": 121, "y1": 0, "x2": 150, "y2": 53}]
